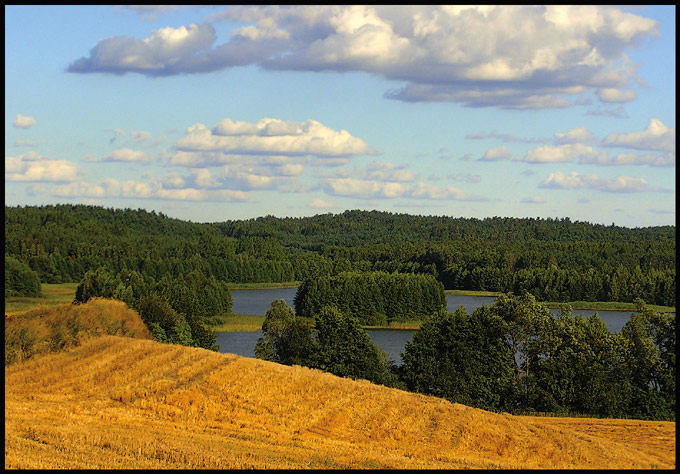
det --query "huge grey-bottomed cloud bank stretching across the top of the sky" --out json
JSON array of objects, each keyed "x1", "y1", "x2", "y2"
[{"x1": 69, "y1": 5, "x2": 659, "y2": 109}]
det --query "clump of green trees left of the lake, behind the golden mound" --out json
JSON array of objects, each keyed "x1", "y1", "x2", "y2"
[{"x1": 74, "y1": 267, "x2": 233, "y2": 351}]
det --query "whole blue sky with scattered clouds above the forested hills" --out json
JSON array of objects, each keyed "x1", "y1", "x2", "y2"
[{"x1": 5, "y1": 5, "x2": 676, "y2": 228}]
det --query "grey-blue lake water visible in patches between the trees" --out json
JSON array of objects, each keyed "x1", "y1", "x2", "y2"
[{"x1": 216, "y1": 288, "x2": 652, "y2": 365}]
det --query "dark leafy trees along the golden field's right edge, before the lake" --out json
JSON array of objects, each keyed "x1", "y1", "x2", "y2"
[{"x1": 255, "y1": 294, "x2": 675, "y2": 420}]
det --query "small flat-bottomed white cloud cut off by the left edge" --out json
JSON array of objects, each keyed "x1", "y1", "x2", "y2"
[{"x1": 5, "y1": 152, "x2": 83, "y2": 182}]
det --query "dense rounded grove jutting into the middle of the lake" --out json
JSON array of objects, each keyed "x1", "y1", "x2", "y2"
[{"x1": 294, "y1": 272, "x2": 446, "y2": 326}]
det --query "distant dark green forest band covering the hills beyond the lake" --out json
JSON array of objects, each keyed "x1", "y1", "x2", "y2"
[{"x1": 5, "y1": 205, "x2": 676, "y2": 306}]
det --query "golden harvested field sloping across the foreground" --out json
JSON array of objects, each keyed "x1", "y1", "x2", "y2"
[{"x1": 5, "y1": 301, "x2": 675, "y2": 469}]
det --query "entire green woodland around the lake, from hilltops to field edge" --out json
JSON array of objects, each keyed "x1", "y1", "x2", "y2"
[{"x1": 5, "y1": 205, "x2": 675, "y2": 419}]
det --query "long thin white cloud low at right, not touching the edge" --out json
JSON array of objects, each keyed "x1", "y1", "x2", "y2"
[{"x1": 539, "y1": 171, "x2": 663, "y2": 193}]
